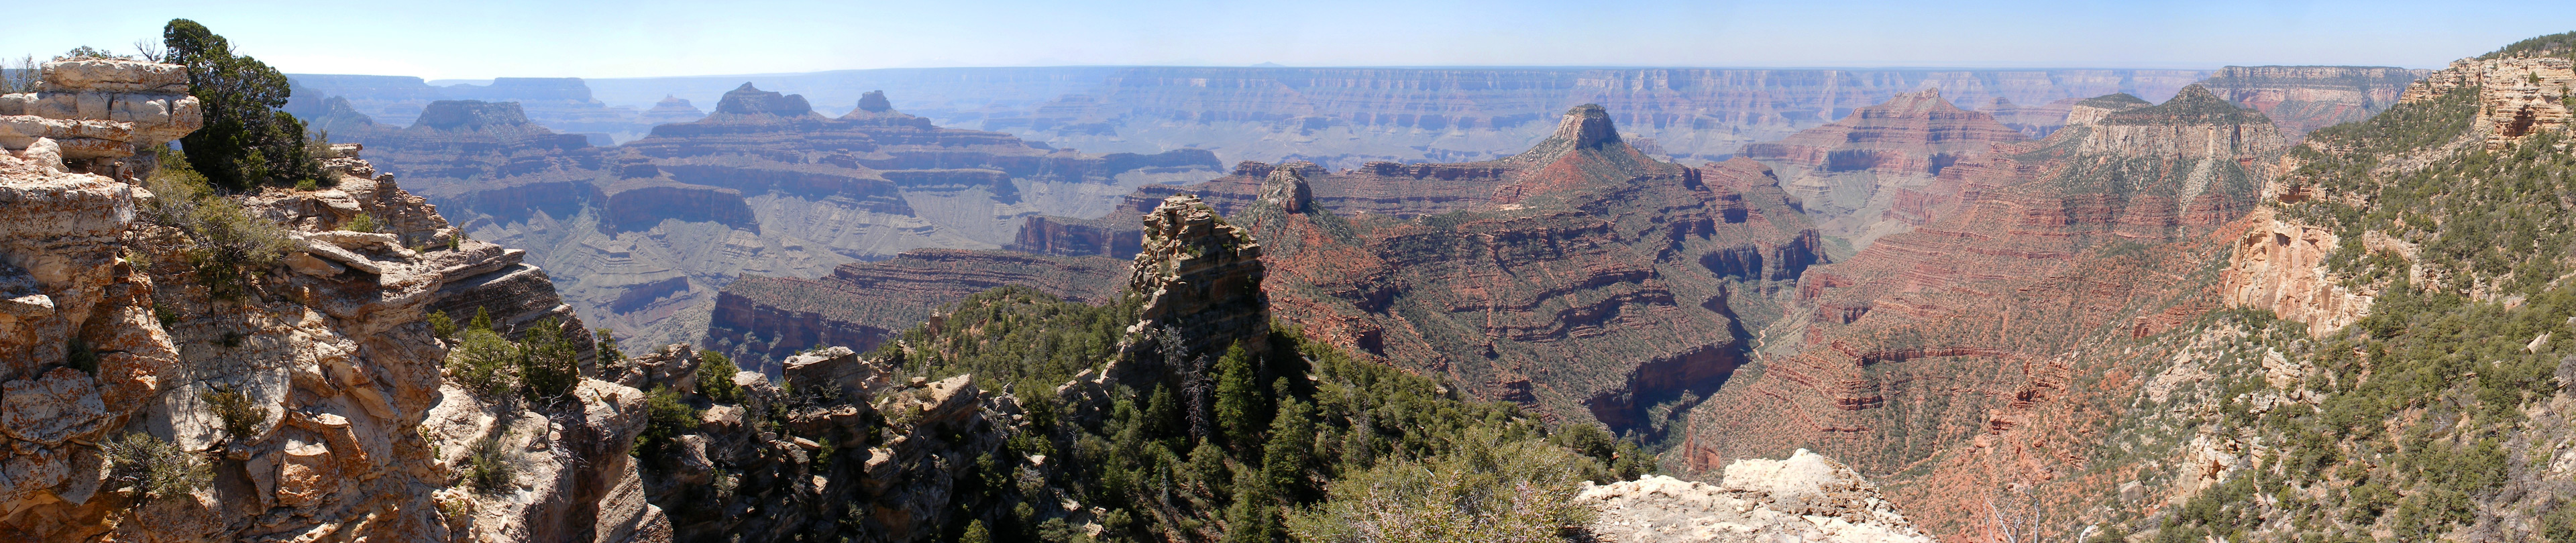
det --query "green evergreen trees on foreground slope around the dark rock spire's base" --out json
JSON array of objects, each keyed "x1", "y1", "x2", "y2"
[{"x1": 868, "y1": 286, "x2": 1654, "y2": 543}]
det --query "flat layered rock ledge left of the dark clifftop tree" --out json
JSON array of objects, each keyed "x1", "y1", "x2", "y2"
[{"x1": 0, "y1": 59, "x2": 206, "y2": 172}]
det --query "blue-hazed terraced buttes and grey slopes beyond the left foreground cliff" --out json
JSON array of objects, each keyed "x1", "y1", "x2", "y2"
[{"x1": 304, "y1": 85, "x2": 1216, "y2": 347}]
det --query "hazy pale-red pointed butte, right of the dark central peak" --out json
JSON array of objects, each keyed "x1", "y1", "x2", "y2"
[{"x1": 1741, "y1": 90, "x2": 2022, "y2": 249}]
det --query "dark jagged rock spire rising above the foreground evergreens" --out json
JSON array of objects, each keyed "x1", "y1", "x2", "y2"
[{"x1": 1126, "y1": 196, "x2": 1270, "y2": 355}]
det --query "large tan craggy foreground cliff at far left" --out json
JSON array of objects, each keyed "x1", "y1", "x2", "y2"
[{"x1": 0, "y1": 59, "x2": 669, "y2": 540}]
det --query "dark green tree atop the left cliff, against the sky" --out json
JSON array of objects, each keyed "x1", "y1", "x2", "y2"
[{"x1": 162, "y1": 18, "x2": 327, "y2": 190}]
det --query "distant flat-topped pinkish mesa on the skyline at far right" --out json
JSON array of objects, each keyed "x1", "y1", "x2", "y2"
[{"x1": 2200, "y1": 67, "x2": 2429, "y2": 139}]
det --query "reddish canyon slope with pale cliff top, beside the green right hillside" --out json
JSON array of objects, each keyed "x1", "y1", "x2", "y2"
[{"x1": 1677, "y1": 88, "x2": 2282, "y2": 538}]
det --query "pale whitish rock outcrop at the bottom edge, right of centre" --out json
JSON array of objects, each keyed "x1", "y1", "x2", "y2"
[{"x1": 1579, "y1": 448, "x2": 1932, "y2": 543}]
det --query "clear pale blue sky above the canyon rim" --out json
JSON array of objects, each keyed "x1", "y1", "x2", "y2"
[{"x1": 0, "y1": 0, "x2": 2576, "y2": 80}]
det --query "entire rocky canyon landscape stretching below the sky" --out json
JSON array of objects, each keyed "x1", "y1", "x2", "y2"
[{"x1": 0, "y1": 7, "x2": 2576, "y2": 543}]
